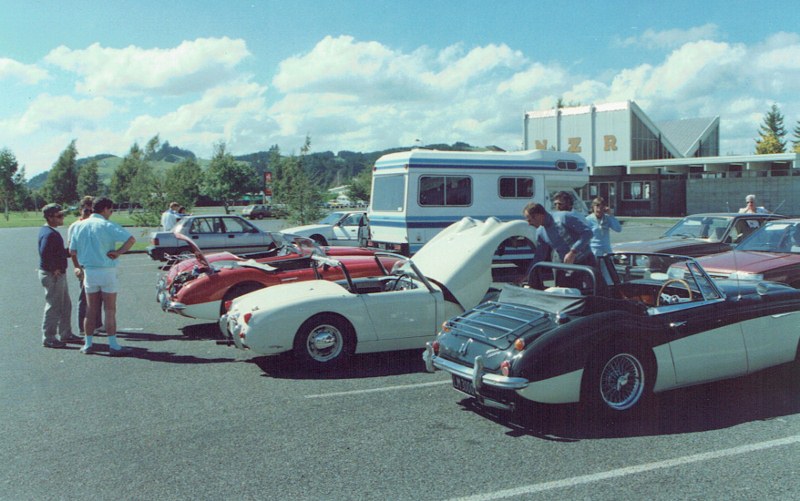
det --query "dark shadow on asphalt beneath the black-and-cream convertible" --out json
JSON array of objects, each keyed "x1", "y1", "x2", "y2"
[{"x1": 459, "y1": 366, "x2": 800, "y2": 442}]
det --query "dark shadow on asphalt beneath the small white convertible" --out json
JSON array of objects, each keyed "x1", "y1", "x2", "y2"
[{"x1": 247, "y1": 349, "x2": 425, "y2": 379}]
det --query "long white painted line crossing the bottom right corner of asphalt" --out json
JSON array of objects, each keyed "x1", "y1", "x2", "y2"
[{"x1": 451, "y1": 435, "x2": 800, "y2": 501}]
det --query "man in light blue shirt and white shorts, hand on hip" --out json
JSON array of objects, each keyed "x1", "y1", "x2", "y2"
[{"x1": 69, "y1": 197, "x2": 136, "y2": 356}]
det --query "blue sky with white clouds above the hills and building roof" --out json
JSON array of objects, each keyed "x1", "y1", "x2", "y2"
[{"x1": 0, "y1": 0, "x2": 800, "y2": 179}]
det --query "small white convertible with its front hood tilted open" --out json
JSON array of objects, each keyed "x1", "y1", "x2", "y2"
[{"x1": 220, "y1": 218, "x2": 531, "y2": 366}]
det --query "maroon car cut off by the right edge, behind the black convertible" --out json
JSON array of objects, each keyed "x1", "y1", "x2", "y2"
[{"x1": 697, "y1": 219, "x2": 800, "y2": 289}]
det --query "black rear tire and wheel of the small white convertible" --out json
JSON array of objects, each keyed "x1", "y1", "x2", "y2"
[{"x1": 293, "y1": 313, "x2": 356, "y2": 368}]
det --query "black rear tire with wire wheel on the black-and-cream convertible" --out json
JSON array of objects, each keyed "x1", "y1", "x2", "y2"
[{"x1": 581, "y1": 342, "x2": 656, "y2": 420}]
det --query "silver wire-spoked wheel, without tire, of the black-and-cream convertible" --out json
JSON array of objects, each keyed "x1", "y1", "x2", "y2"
[{"x1": 600, "y1": 353, "x2": 644, "y2": 411}]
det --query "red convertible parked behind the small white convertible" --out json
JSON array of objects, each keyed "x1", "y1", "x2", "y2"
[{"x1": 156, "y1": 234, "x2": 397, "y2": 321}]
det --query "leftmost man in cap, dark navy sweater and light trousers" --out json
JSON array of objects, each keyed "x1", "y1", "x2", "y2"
[{"x1": 39, "y1": 204, "x2": 81, "y2": 348}]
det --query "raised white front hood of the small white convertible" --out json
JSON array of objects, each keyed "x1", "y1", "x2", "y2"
[{"x1": 412, "y1": 217, "x2": 534, "y2": 309}]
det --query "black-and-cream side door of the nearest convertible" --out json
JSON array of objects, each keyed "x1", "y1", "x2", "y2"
[{"x1": 661, "y1": 300, "x2": 747, "y2": 386}]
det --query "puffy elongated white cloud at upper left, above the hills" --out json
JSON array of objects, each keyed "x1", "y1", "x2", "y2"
[{"x1": 45, "y1": 37, "x2": 250, "y2": 96}]
